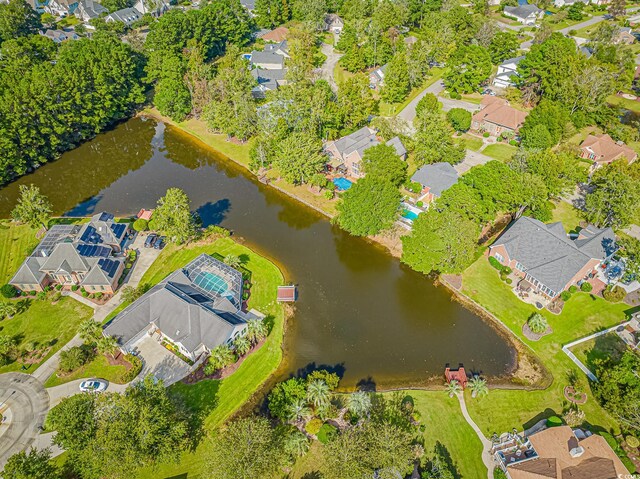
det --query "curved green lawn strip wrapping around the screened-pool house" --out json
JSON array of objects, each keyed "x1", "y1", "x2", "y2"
[{"x1": 138, "y1": 238, "x2": 284, "y2": 479}]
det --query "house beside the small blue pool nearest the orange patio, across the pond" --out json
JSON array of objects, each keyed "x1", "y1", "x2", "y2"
[{"x1": 324, "y1": 126, "x2": 407, "y2": 178}]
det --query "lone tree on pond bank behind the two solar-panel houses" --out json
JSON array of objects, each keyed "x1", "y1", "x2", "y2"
[{"x1": 153, "y1": 188, "x2": 196, "y2": 244}]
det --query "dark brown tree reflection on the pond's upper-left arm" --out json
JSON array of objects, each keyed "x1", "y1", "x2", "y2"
[{"x1": 0, "y1": 118, "x2": 156, "y2": 217}]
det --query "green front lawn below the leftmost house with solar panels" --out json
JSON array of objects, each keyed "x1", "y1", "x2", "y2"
[{"x1": 0, "y1": 297, "x2": 93, "y2": 373}]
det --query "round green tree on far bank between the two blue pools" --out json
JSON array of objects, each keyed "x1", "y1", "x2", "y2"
[{"x1": 336, "y1": 176, "x2": 400, "y2": 236}]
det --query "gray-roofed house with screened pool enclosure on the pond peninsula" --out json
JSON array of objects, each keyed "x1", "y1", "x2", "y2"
[{"x1": 104, "y1": 254, "x2": 264, "y2": 361}]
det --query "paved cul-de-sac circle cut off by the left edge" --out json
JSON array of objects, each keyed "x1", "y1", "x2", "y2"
[{"x1": 0, "y1": 373, "x2": 49, "y2": 469}]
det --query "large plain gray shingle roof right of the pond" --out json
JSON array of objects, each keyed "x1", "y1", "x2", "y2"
[{"x1": 493, "y1": 216, "x2": 615, "y2": 292}]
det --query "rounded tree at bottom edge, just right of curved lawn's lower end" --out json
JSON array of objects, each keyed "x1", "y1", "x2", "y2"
[{"x1": 208, "y1": 416, "x2": 285, "y2": 479}]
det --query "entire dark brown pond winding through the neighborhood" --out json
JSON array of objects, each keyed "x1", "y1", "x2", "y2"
[{"x1": 0, "y1": 119, "x2": 515, "y2": 386}]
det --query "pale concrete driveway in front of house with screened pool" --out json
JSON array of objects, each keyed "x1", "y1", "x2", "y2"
[{"x1": 136, "y1": 336, "x2": 191, "y2": 386}]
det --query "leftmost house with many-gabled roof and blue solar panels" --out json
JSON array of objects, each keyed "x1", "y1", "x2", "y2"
[{"x1": 9, "y1": 213, "x2": 130, "y2": 293}]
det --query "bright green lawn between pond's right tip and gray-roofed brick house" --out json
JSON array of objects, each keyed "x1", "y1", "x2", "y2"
[{"x1": 463, "y1": 256, "x2": 629, "y2": 436}]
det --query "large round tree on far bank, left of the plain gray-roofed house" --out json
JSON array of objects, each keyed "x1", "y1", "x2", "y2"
[{"x1": 402, "y1": 206, "x2": 479, "y2": 274}]
